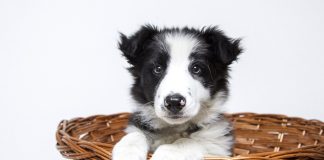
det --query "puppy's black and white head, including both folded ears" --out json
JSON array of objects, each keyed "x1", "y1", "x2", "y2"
[{"x1": 119, "y1": 26, "x2": 241, "y2": 124}]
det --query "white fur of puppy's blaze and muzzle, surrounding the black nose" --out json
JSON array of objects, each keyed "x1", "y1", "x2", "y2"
[{"x1": 154, "y1": 34, "x2": 209, "y2": 124}]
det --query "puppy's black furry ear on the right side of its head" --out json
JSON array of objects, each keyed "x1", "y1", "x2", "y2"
[{"x1": 202, "y1": 27, "x2": 242, "y2": 65}]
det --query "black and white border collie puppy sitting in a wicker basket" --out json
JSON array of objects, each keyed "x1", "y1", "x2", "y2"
[{"x1": 112, "y1": 25, "x2": 241, "y2": 160}]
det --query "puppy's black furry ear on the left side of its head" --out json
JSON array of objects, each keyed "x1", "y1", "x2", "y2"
[{"x1": 118, "y1": 25, "x2": 158, "y2": 65}]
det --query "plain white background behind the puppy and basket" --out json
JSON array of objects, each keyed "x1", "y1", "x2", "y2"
[{"x1": 0, "y1": 0, "x2": 324, "y2": 160}]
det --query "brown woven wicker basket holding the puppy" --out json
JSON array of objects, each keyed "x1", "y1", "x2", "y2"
[{"x1": 56, "y1": 113, "x2": 324, "y2": 160}]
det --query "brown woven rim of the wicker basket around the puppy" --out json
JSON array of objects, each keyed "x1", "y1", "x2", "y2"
[{"x1": 56, "y1": 112, "x2": 324, "y2": 160}]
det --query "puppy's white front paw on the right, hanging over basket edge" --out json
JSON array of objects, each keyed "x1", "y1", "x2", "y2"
[{"x1": 151, "y1": 144, "x2": 203, "y2": 160}]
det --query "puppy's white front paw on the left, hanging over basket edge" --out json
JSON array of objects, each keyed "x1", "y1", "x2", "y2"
[{"x1": 112, "y1": 132, "x2": 148, "y2": 160}]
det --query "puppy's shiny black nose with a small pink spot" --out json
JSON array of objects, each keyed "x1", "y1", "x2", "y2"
[{"x1": 164, "y1": 94, "x2": 186, "y2": 113}]
